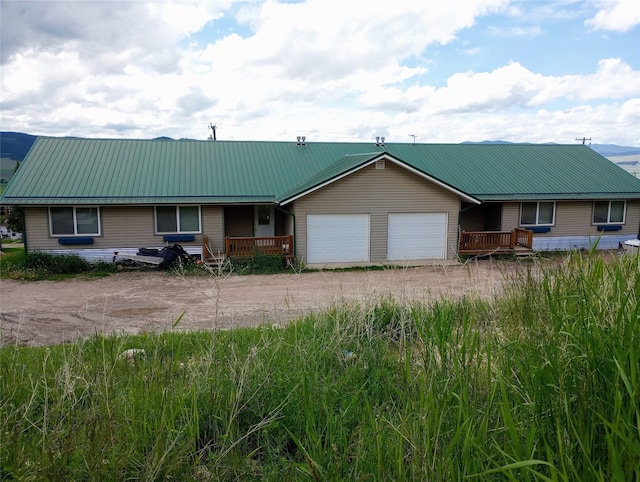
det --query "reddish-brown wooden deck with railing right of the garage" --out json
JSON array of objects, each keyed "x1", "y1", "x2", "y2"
[{"x1": 458, "y1": 228, "x2": 533, "y2": 255}]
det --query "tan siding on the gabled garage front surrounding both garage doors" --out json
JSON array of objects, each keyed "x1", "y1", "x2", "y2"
[{"x1": 295, "y1": 161, "x2": 460, "y2": 263}]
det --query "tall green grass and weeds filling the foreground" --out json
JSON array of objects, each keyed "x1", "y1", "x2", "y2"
[{"x1": 0, "y1": 250, "x2": 640, "y2": 481}]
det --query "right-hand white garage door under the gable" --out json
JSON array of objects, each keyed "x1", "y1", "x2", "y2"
[{"x1": 387, "y1": 213, "x2": 447, "y2": 261}]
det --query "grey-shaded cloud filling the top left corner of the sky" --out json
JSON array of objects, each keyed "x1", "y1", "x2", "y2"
[{"x1": 0, "y1": 0, "x2": 230, "y2": 64}]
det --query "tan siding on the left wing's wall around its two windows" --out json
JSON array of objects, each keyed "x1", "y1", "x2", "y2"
[{"x1": 25, "y1": 206, "x2": 224, "y2": 250}]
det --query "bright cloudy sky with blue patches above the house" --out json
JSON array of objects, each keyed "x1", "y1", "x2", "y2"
[{"x1": 0, "y1": 0, "x2": 640, "y2": 146}]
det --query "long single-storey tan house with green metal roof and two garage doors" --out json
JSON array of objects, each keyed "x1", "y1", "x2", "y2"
[{"x1": 0, "y1": 137, "x2": 640, "y2": 266}]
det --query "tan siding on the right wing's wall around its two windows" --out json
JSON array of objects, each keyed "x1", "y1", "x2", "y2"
[{"x1": 502, "y1": 201, "x2": 640, "y2": 237}]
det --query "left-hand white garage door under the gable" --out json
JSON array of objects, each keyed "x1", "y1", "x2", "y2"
[{"x1": 307, "y1": 214, "x2": 369, "y2": 263}]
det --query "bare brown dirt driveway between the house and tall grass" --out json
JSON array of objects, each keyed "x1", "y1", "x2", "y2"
[{"x1": 0, "y1": 260, "x2": 531, "y2": 345}]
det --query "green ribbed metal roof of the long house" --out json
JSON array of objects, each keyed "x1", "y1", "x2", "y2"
[{"x1": 0, "y1": 138, "x2": 640, "y2": 205}]
